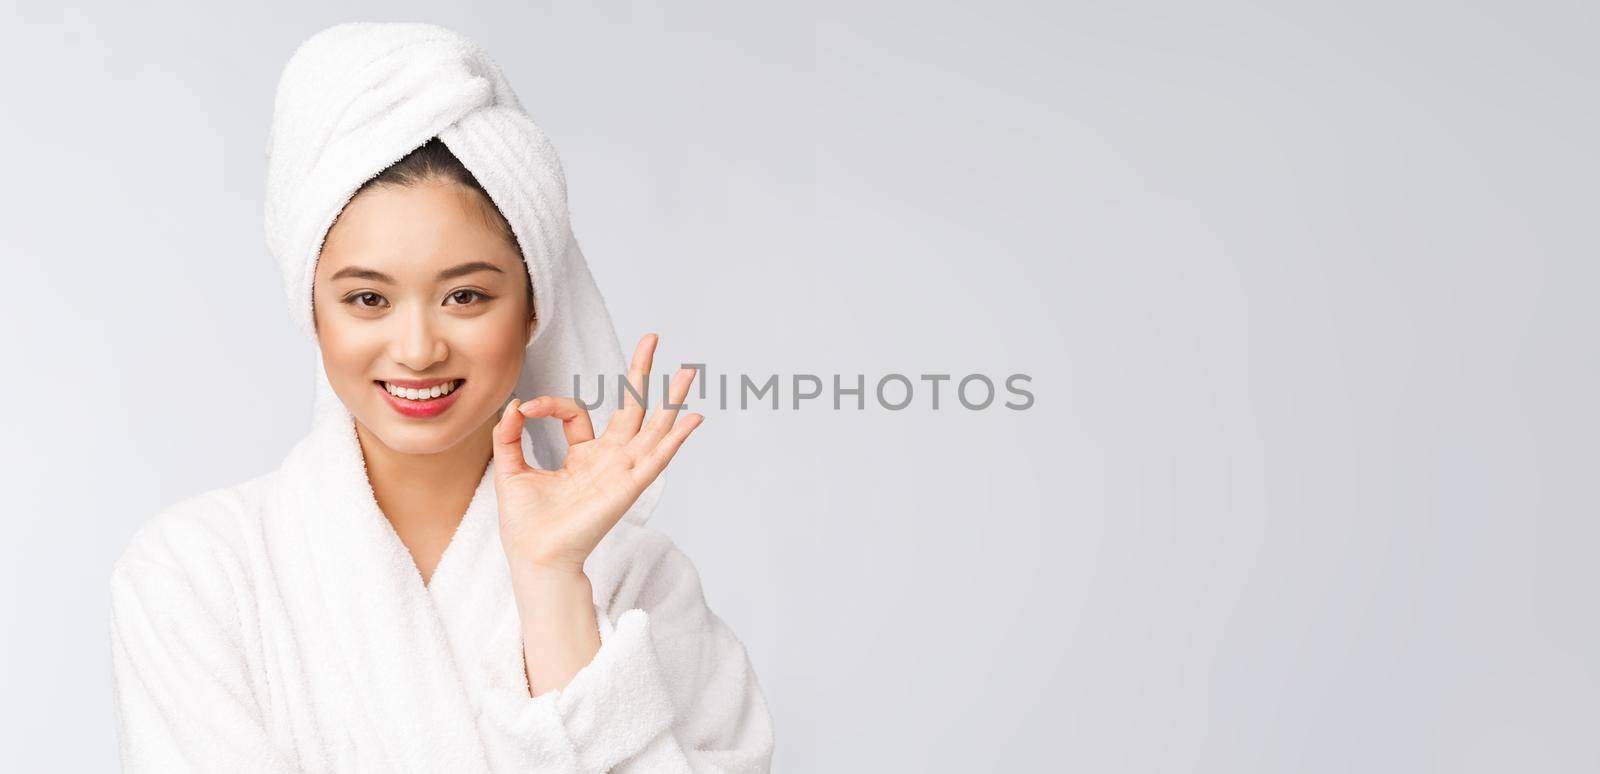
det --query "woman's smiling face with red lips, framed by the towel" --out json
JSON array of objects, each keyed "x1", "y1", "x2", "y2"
[{"x1": 312, "y1": 181, "x2": 534, "y2": 454}]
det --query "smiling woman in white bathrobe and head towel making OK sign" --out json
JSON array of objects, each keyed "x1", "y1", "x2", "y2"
[{"x1": 110, "y1": 22, "x2": 773, "y2": 772}]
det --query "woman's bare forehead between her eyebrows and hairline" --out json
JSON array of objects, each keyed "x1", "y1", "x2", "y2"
[{"x1": 317, "y1": 182, "x2": 522, "y2": 281}]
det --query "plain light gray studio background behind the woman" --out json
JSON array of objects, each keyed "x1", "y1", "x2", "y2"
[{"x1": 0, "y1": 2, "x2": 1600, "y2": 772}]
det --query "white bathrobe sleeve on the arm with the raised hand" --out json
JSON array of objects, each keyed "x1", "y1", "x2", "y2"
[{"x1": 480, "y1": 533, "x2": 773, "y2": 774}]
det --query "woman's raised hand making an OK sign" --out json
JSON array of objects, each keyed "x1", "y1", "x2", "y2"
[{"x1": 494, "y1": 334, "x2": 704, "y2": 573}]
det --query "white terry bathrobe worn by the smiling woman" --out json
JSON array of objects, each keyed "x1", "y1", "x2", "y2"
[{"x1": 110, "y1": 396, "x2": 773, "y2": 774}]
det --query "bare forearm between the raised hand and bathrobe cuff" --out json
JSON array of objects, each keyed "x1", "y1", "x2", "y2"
[{"x1": 510, "y1": 563, "x2": 600, "y2": 697}]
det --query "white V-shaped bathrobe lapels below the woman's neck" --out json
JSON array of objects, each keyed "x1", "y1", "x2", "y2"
[{"x1": 285, "y1": 411, "x2": 505, "y2": 772}]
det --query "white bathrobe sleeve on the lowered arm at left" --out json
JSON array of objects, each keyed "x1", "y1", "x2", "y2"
[{"x1": 110, "y1": 505, "x2": 298, "y2": 772}]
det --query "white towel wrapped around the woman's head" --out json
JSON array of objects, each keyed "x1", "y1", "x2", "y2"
[{"x1": 266, "y1": 22, "x2": 652, "y2": 505}]
